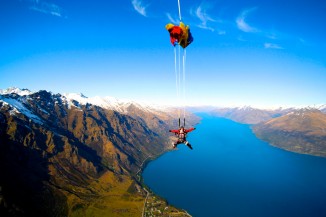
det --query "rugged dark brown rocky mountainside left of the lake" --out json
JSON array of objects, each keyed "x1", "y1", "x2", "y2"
[{"x1": 0, "y1": 90, "x2": 199, "y2": 216}]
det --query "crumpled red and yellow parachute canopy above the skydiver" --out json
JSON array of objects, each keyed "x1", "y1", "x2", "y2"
[{"x1": 165, "y1": 22, "x2": 194, "y2": 48}]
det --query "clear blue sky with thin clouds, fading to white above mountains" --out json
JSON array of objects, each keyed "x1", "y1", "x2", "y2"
[{"x1": 0, "y1": 0, "x2": 326, "y2": 106}]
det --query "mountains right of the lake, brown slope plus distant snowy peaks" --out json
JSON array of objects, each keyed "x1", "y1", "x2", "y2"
[{"x1": 210, "y1": 105, "x2": 326, "y2": 157}]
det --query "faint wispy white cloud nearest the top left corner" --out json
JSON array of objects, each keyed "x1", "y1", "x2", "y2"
[{"x1": 26, "y1": 0, "x2": 63, "y2": 17}]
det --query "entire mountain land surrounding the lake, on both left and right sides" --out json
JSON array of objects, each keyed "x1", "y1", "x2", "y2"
[{"x1": 0, "y1": 88, "x2": 326, "y2": 216}]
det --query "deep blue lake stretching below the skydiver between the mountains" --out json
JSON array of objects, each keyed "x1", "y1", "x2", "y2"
[{"x1": 143, "y1": 116, "x2": 326, "y2": 217}]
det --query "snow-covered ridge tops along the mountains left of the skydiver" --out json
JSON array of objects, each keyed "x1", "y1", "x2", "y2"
[{"x1": 0, "y1": 88, "x2": 181, "y2": 124}]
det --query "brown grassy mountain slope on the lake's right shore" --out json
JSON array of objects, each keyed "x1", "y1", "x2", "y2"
[{"x1": 253, "y1": 109, "x2": 326, "y2": 156}]
